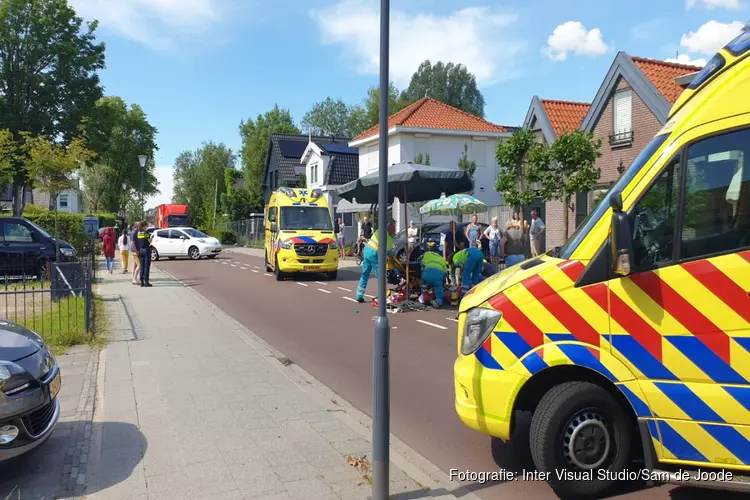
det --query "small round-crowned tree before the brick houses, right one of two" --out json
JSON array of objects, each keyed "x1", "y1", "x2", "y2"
[{"x1": 539, "y1": 130, "x2": 602, "y2": 238}]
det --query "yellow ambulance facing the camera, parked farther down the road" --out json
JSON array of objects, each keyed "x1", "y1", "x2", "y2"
[{"x1": 265, "y1": 187, "x2": 339, "y2": 281}]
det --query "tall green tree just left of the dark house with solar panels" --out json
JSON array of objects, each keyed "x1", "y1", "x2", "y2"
[{"x1": 240, "y1": 105, "x2": 300, "y2": 207}]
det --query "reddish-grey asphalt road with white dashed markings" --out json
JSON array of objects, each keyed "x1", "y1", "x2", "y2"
[{"x1": 154, "y1": 253, "x2": 739, "y2": 500}]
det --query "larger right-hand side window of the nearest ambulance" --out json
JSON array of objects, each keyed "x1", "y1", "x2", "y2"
[{"x1": 680, "y1": 129, "x2": 750, "y2": 259}]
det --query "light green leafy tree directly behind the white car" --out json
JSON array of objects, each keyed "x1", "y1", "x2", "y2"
[{"x1": 173, "y1": 142, "x2": 235, "y2": 227}]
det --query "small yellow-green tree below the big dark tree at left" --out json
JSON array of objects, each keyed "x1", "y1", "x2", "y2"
[{"x1": 22, "y1": 132, "x2": 93, "y2": 207}]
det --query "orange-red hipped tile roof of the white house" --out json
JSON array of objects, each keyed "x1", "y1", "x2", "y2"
[{"x1": 352, "y1": 97, "x2": 510, "y2": 141}]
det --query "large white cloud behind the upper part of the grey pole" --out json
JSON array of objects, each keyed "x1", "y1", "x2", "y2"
[{"x1": 310, "y1": 0, "x2": 523, "y2": 87}]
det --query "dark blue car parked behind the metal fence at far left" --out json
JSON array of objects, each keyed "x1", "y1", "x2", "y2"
[{"x1": 0, "y1": 217, "x2": 77, "y2": 278}]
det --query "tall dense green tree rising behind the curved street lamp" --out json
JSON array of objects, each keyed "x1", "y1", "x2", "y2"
[{"x1": 82, "y1": 96, "x2": 159, "y2": 212}]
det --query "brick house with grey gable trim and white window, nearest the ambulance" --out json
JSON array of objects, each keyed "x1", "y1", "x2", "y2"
[{"x1": 579, "y1": 52, "x2": 701, "y2": 214}]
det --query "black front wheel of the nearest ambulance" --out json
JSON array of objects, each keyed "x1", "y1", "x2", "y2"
[{"x1": 529, "y1": 382, "x2": 635, "y2": 499}]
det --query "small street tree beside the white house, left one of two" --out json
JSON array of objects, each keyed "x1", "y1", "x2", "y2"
[{"x1": 495, "y1": 129, "x2": 549, "y2": 229}]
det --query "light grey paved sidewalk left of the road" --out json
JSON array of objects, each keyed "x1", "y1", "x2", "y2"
[{"x1": 84, "y1": 268, "x2": 471, "y2": 500}]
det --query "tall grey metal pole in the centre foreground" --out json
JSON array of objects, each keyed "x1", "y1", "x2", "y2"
[{"x1": 372, "y1": 0, "x2": 390, "y2": 500}]
